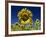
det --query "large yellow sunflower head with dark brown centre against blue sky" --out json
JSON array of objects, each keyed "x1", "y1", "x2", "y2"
[{"x1": 17, "y1": 8, "x2": 33, "y2": 25}]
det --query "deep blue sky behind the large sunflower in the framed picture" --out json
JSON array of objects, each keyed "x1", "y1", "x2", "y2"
[{"x1": 11, "y1": 6, "x2": 41, "y2": 24}]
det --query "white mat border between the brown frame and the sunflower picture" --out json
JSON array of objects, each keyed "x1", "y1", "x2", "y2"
[{"x1": 8, "y1": 3, "x2": 43, "y2": 34}]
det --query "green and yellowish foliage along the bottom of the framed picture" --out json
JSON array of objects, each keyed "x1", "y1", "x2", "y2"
[{"x1": 11, "y1": 19, "x2": 40, "y2": 31}]
